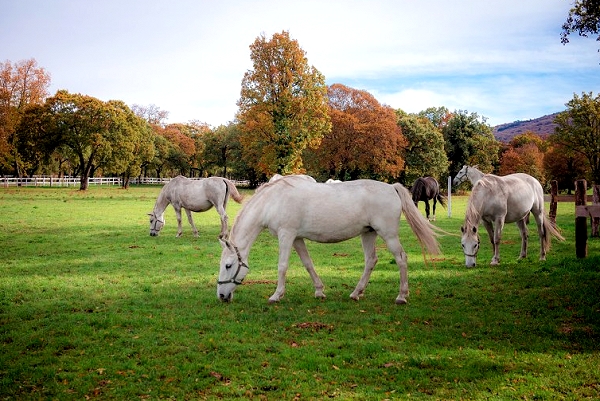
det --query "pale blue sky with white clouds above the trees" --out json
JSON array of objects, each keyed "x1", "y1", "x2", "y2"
[{"x1": 0, "y1": 0, "x2": 600, "y2": 127}]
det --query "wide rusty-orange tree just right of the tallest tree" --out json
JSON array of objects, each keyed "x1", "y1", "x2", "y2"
[{"x1": 310, "y1": 84, "x2": 406, "y2": 180}]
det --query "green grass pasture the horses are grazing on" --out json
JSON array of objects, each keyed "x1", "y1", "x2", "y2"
[{"x1": 0, "y1": 186, "x2": 600, "y2": 400}]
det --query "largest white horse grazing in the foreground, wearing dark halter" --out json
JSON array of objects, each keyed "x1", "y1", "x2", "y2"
[{"x1": 217, "y1": 176, "x2": 439, "y2": 304}]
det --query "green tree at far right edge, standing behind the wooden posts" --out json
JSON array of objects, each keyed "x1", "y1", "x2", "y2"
[{"x1": 549, "y1": 92, "x2": 600, "y2": 184}]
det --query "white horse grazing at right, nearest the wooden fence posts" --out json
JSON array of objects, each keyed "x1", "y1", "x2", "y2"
[{"x1": 461, "y1": 172, "x2": 564, "y2": 267}]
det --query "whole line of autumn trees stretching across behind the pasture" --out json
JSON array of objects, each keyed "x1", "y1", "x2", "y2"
[{"x1": 0, "y1": 31, "x2": 600, "y2": 189}]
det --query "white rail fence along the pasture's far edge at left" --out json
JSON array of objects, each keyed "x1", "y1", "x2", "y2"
[{"x1": 0, "y1": 176, "x2": 249, "y2": 188}]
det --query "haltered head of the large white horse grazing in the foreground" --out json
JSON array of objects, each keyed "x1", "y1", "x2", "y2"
[{"x1": 217, "y1": 238, "x2": 250, "y2": 302}]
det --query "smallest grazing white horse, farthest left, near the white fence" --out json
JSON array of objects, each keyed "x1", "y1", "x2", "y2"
[{"x1": 148, "y1": 175, "x2": 244, "y2": 237}]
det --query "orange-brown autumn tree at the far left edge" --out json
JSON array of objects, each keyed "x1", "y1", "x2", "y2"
[{"x1": 0, "y1": 59, "x2": 50, "y2": 176}]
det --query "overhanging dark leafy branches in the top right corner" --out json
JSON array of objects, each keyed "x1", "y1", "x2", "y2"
[{"x1": 560, "y1": 0, "x2": 600, "y2": 48}]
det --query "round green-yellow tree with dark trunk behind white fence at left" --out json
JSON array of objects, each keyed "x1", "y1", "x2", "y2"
[{"x1": 39, "y1": 90, "x2": 145, "y2": 190}]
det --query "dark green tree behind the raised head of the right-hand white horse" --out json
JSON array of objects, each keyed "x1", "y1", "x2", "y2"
[{"x1": 442, "y1": 110, "x2": 500, "y2": 176}]
